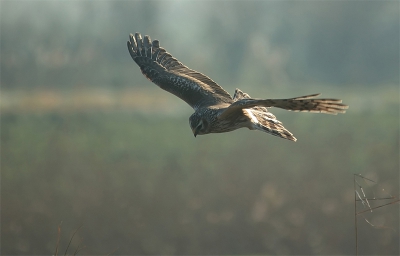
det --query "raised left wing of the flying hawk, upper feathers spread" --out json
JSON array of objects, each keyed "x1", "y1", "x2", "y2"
[{"x1": 128, "y1": 33, "x2": 233, "y2": 110}]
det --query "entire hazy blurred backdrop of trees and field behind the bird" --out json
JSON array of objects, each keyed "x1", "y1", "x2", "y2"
[{"x1": 0, "y1": 0, "x2": 400, "y2": 255}]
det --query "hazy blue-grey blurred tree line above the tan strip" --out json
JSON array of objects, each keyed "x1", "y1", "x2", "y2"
[{"x1": 0, "y1": 0, "x2": 399, "y2": 89}]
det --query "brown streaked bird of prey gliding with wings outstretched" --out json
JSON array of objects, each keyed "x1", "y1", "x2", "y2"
[{"x1": 128, "y1": 33, "x2": 348, "y2": 141}]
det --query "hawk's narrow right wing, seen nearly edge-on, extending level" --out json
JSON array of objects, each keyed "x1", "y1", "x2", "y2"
[{"x1": 218, "y1": 93, "x2": 348, "y2": 119}]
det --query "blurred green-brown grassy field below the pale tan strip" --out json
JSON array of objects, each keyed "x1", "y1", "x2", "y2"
[{"x1": 1, "y1": 89, "x2": 399, "y2": 255}]
